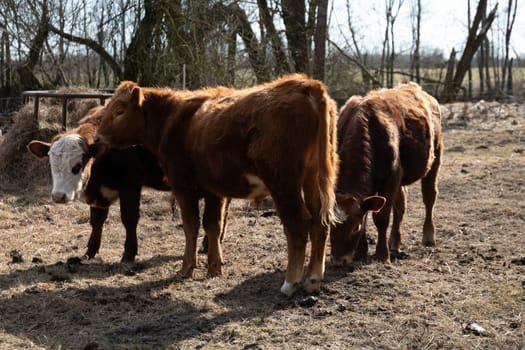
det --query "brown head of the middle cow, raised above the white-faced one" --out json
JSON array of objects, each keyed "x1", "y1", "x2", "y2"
[{"x1": 96, "y1": 81, "x2": 145, "y2": 148}]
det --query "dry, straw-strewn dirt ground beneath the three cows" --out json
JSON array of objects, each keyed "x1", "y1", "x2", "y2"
[{"x1": 0, "y1": 103, "x2": 525, "y2": 349}]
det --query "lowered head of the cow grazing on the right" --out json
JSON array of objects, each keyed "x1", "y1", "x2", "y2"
[{"x1": 330, "y1": 193, "x2": 386, "y2": 265}]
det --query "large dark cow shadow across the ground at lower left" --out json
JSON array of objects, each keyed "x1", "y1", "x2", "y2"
[{"x1": 0, "y1": 252, "x2": 368, "y2": 349}]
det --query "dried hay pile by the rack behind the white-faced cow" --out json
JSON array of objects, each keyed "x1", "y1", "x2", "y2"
[{"x1": 0, "y1": 88, "x2": 105, "y2": 192}]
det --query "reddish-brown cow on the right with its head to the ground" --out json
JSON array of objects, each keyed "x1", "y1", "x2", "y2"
[{"x1": 330, "y1": 83, "x2": 443, "y2": 264}]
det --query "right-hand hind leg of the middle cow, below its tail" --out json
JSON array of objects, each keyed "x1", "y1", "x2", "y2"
[{"x1": 303, "y1": 175, "x2": 330, "y2": 293}]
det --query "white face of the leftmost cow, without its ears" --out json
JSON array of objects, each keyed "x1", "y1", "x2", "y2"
[{"x1": 48, "y1": 134, "x2": 87, "y2": 203}]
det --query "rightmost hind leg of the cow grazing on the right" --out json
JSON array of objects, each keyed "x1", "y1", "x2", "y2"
[{"x1": 421, "y1": 150, "x2": 441, "y2": 247}]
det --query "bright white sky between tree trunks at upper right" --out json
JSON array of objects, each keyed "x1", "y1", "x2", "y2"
[{"x1": 330, "y1": 0, "x2": 525, "y2": 57}]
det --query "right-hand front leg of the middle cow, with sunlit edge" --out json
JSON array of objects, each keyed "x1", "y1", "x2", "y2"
[{"x1": 202, "y1": 195, "x2": 227, "y2": 276}]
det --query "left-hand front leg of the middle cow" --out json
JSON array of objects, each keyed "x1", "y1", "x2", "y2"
[{"x1": 176, "y1": 194, "x2": 200, "y2": 278}]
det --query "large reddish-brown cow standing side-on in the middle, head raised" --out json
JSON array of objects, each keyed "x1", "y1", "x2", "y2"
[{"x1": 97, "y1": 75, "x2": 338, "y2": 295}]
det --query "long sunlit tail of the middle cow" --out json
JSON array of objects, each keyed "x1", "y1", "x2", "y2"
[{"x1": 312, "y1": 82, "x2": 340, "y2": 225}]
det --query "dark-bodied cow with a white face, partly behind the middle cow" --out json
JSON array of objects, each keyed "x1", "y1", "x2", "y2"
[{"x1": 27, "y1": 106, "x2": 169, "y2": 262}]
